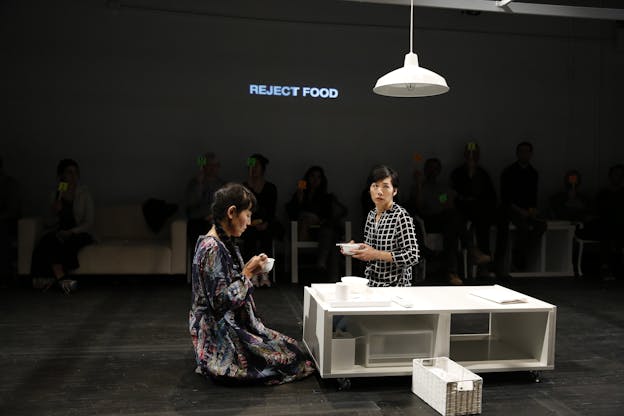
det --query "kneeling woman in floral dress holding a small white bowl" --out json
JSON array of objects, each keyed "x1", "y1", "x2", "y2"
[{"x1": 189, "y1": 184, "x2": 314, "y2": 384}]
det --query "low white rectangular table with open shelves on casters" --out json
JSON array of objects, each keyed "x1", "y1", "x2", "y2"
[{"x1": 303, "y1": 284, "x2": 557, "y2": 378}]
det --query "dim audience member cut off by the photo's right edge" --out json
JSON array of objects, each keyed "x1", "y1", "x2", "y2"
[{"x1": 578, "y1": 164, "x2": 624, "y2": 280}]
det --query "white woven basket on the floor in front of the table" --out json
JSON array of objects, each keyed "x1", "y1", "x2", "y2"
[{"x1": 412, "y1": 357, "x2": 483, "y2": 416}]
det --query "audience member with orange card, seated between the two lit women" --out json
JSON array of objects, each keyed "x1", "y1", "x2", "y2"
[{"x1": 286, "y1": 166, "x2": 347, "y2": 276}]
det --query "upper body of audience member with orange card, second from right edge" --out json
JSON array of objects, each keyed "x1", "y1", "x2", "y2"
[{"x1": 549, "y1": 170, "x2": 592, "y2": 223}]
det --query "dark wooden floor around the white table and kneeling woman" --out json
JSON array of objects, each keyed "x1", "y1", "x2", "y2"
[{"x1": 0, "y1": 277, "x2": 624, "y2": 416}]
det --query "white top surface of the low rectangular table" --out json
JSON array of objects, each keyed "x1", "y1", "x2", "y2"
[{"x1": 304, "y1": 283, "x2": 556, "y2": 313}]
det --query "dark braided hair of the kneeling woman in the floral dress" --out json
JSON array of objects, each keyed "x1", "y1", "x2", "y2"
[{"x1": 212, "y1": 183, "x2": 257, "y2": 270}]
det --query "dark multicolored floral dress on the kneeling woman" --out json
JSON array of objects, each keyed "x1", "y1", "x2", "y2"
[{"x1": 189, "y1": 236, "x2": 314, "y2": 384}]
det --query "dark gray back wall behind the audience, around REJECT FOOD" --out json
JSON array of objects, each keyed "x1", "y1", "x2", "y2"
[{"x1": 0, "y1": 0, "x2": 624, "y2": 231}]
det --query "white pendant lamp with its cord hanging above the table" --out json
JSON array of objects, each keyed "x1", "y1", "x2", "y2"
[{"x1": 373, "y1": 0, "x2": 449, "y2": 97}]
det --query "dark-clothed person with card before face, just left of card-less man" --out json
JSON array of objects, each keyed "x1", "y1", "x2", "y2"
[{"x1": 451, "y1": 142, "x2": 496, "y2": 265}]
